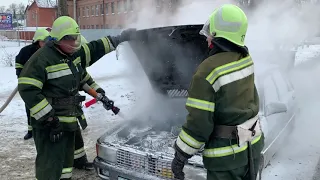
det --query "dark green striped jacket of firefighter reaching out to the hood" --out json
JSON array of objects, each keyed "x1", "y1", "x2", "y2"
[{"x1": 18, "y1": 38, "x2": 114, "y2": 131}]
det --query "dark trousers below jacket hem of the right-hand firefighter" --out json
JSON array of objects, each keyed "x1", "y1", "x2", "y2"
[{"x1": 207, "y1": 159, "x2": 260, "y2": 180}]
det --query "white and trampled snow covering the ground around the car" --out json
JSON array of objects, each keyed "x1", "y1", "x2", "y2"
[{"x1": 0, "y1": 41, "x2": 320, "y2": 180}]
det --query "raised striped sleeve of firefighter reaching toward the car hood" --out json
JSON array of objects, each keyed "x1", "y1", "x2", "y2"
[{"x1": 77, "y1": 37, "x2": 115, "y2": 69}]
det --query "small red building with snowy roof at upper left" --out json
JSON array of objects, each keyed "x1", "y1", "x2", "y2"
[{"x1": 25, "y1": 0, "x2": 57, "y2": 27}]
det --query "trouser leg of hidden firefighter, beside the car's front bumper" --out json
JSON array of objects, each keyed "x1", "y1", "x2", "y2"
[{"x1": 73, "y1": 128, "x2": 88, "y2": 168}]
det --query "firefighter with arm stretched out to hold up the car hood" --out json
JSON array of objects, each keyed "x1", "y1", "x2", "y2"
[{"x1": 18, "y1": 16, "x2": 135, "y2": 180}]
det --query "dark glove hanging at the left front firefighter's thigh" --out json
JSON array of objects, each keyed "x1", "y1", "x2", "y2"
[{"x1": 45, "y1": 117, "x2": 63, "y2": 143}]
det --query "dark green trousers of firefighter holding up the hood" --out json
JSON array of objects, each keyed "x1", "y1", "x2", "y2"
[{"x1": 33, "y1": 128, "x2": 75, "y2": 180}]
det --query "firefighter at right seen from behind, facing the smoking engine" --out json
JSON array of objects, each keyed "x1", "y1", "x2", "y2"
[{"x1": 171, "y1": 4, "x2": 264, "y2": 180}]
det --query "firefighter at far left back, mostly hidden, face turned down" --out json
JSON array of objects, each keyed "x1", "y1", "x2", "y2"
[{"x1": 15, "y1": 28, "x2": 49, "y2": 140}]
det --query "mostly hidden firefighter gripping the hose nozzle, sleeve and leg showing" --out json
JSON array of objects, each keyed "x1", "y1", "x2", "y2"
[{"x1": 73, "y1": 35, "x2": 105, "y2": 170}]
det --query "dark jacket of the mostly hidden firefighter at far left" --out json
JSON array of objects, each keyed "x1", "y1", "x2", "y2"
[{"x1": 15, "y1": 43, "x2": 40, "y2": 77}]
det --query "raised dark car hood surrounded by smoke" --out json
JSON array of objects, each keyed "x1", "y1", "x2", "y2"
[{"x1": 130, "y1": 25, "x2": 208, "y2": 97}]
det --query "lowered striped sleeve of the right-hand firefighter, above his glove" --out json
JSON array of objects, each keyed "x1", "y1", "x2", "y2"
[{"x1": 176, "y1": 74, "x2": 215, "y2": 156}]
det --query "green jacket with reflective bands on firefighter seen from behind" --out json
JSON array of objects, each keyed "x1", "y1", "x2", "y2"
[{"x1": 176, "y1": 40, "x2": 264, "y2": 171}]
